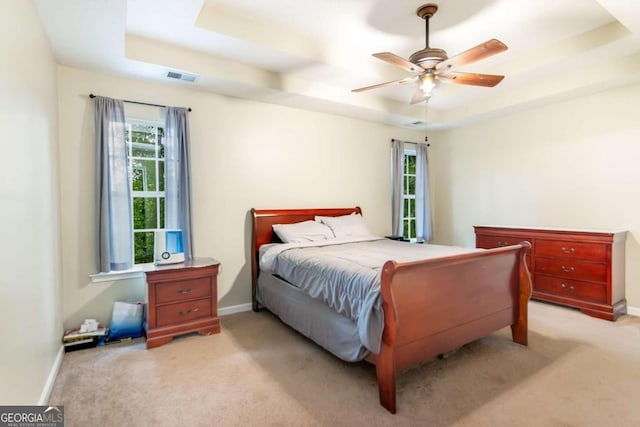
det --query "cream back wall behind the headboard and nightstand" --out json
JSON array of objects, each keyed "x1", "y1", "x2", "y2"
[{"x1": 58, "y1": 66, "x2": 422, "y2": 326}]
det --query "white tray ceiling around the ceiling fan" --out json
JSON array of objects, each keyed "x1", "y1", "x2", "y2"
[{"x1": 33, "y1": 0, "x2": 640, "y2": 128}]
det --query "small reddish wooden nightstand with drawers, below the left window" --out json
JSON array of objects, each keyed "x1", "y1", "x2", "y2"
[{"x1": 145, "y1": 258, "x2": 220, "y2": 348}]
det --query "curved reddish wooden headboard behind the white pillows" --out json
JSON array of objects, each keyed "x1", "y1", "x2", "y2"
[{"x1": 251, "y1": 206, "x2": 362, "y2": 311}]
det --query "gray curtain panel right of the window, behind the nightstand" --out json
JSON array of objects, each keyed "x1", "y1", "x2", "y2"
[{"x1": 165, "y1": 107, "x2": 194, "y2": 259}]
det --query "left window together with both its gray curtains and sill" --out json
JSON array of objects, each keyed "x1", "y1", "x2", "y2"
[{"x1": 92, "y1": 96, "x2": 193, "y2": 281}]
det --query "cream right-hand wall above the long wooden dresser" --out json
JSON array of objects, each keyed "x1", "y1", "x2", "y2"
[{"x1": 431, "y1": 85, "x2": 640, "y2": 314}]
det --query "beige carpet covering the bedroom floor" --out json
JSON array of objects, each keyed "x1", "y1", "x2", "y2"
[{"x1": 50, "y1": 302, "x2": 640, "y2": 427}]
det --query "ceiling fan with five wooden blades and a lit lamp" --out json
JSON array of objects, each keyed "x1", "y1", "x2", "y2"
[{"x1": 352, "y1": 3, "x2": 508, "y2": 104}]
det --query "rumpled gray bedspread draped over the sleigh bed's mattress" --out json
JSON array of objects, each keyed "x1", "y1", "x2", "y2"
[{"x1": 260, "y1": 237, "x2": 476, "y2": 353}]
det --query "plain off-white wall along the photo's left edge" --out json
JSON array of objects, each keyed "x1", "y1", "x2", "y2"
[{"x1": 0, "y1": 0, "x2": 62, "y2": 405}]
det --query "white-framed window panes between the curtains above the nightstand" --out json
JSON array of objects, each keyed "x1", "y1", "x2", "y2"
[{"x1": 126, "y1": 118, "x2": 165, "y2": 264}]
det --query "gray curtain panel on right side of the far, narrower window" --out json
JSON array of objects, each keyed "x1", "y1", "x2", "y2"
[{"x1": 416, "y1": 143, "x2": 433, "y2": 242}]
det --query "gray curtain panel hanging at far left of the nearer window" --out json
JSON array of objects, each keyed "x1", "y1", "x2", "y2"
[{"x1": 94, "y1": 96, "x2": 133, "y2": 272}]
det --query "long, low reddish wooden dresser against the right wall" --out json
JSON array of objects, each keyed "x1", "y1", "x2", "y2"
[{"x1": 474, "y1": 226, "x2": 627, "y2": 320}]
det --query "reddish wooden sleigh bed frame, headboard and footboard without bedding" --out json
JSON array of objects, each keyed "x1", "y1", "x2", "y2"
[{"x1": 251, "y1": 207, "x2": 531, "y2": 413}]
